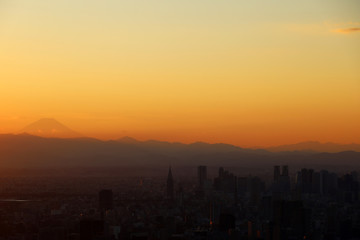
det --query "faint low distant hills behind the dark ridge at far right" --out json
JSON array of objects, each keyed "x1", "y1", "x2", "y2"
[{"x1": 265, "y1": 141, "x2": 360, "y2": 153}]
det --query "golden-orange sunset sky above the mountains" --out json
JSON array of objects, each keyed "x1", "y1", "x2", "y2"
[{"x1": 0, "y1": 0, "x2": 360, "y2": 147}]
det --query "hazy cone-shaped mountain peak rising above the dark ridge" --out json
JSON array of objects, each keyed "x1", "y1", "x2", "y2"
[{"x1": 20, "y1": 118, "x2": 82, "y2": 138}]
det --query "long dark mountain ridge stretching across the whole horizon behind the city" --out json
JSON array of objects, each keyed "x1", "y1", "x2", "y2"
[{"x1": 0, "y1": 134, "x2": 360, "y2": 169}]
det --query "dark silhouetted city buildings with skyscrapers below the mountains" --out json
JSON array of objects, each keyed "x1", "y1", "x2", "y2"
[{"x1": 0, "y1": 166, "x2": 360, "y2": 240}]
